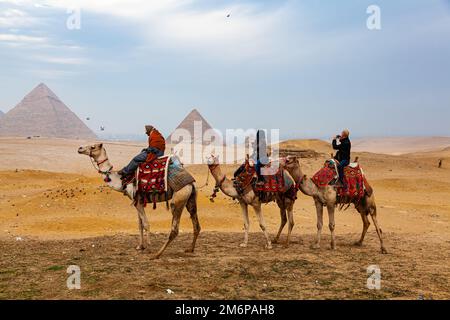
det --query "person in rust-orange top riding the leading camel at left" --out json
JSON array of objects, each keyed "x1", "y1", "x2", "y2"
[{"x1": 118, "y1": 125, "x2": 166, "y2": 179}]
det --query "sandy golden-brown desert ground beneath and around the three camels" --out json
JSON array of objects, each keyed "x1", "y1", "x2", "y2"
[{"x1": 0, "y1": 139, "x2": 450, "y2": 299}]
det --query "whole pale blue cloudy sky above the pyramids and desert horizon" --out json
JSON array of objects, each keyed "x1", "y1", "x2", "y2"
[{"x1": 0, "y1": 0, "x2": 450, "y2": 138}]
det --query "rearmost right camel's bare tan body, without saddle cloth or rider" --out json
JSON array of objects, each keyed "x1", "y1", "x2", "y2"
[{"x1": 282, "y1": 157, "x2": 387, "y2": 253}]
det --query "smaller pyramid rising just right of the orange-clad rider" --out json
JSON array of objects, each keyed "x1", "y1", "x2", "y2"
[{"x1": 167, "y1": 109, "x2": 220, "y2": 145}]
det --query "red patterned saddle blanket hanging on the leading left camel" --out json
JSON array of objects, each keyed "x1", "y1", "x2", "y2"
[{"x1": 137, "y1": 157, "x2": 169, "y2": 194}]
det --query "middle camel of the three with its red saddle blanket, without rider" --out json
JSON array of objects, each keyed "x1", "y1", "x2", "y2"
[{"x1": 208, "y1": 156, "x2": 297, "y2": 249}]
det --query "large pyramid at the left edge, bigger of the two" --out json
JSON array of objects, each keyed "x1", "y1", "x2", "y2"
[{"x1": 0, "y1": 83, "x2": 97, "y2": 139}]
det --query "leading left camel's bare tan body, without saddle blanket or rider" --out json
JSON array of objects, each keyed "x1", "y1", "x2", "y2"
[{"x1": 78, "y1": 143, "x2": 200, "y2": 259}]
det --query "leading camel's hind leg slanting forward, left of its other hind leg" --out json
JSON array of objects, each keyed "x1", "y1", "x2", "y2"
[{"x1": 152, "y1": 185, "x2": 193, "y2": 259}]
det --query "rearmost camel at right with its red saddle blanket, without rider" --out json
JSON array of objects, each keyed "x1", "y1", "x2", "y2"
[{"x1": 282, "y1": 157, "x2": 387, "y2": 253}]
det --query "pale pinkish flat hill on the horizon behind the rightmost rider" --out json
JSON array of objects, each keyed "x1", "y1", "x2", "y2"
[{"x1": 352, "y1": 137, "x2": 450, "y2": 155}]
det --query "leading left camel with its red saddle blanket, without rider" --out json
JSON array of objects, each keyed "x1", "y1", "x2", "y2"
[{"x1": 78, "y1": 144, "x2": 200, "y2": 259}]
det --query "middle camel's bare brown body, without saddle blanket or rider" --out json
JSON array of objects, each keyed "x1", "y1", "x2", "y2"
[{"x1": 208, "y1": 156, "x2": 295, "y2": 249}]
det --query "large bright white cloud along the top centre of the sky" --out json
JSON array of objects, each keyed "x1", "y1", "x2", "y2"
[{"x1": 0, "y1": 0, "x2": 289, "y2": 59}]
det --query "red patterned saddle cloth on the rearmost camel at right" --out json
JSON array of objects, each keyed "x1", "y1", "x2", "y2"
[{"x1": 312, "y1": 160, "x2": 372, "y2": 203}]
